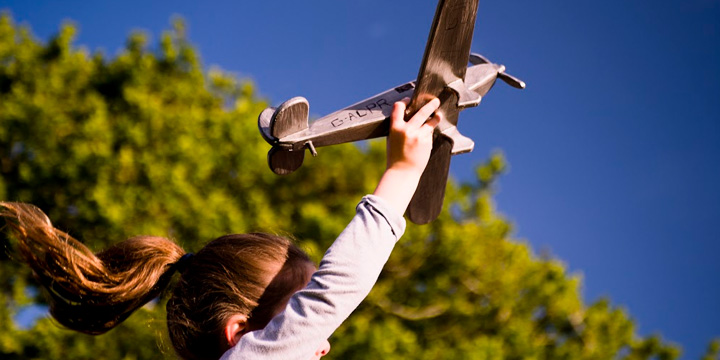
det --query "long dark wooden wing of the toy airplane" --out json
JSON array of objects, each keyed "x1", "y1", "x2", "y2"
[{"x1": 406, "y1": 0, "x2": 480, "y2": 224}]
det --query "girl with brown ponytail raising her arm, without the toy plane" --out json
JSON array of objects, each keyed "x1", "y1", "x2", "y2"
[{"x1": 0, "y1": 99, "x2": 440, "y2": 360}]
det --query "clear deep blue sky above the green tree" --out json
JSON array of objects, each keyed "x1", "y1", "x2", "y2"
[{"x1": 5, "y1": 0, "x2": 720, "y2": 359}]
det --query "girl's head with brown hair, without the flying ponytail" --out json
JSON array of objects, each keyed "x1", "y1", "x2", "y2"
[{"x1": 167, "y1": 233, "x2": 314, "y2": 359}]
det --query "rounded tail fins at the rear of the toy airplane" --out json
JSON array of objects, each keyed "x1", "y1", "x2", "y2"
[{"x1": 258, "y1": 96, "x2": 310, "y2": 175}]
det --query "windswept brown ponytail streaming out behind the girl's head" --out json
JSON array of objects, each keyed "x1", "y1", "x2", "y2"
[{"x1": 0, "y1": 202, "x2": 185, "y2": 335}]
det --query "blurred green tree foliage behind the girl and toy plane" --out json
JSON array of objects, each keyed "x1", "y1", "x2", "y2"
[{"x1": 0, "y1": 15, "x2": 688, "y2": 359}]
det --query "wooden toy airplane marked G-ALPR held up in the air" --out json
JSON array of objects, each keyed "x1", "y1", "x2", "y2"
[{"x1": 258, "y1": 0, "x2": 525, "y2": 224}]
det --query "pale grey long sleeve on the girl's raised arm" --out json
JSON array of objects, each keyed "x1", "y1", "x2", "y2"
[{"x1": 221, "y1": 195, "x2": 406, "y2": 360}]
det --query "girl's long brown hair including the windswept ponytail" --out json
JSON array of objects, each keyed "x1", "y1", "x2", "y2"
[{"x1": 0, "y1": 202, "x2": 311, "y2": 360}]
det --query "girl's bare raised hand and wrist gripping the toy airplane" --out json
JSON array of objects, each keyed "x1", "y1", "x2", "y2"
[{"x1": 373, "y1": 99, "x2": 440, "y2": 214}]
